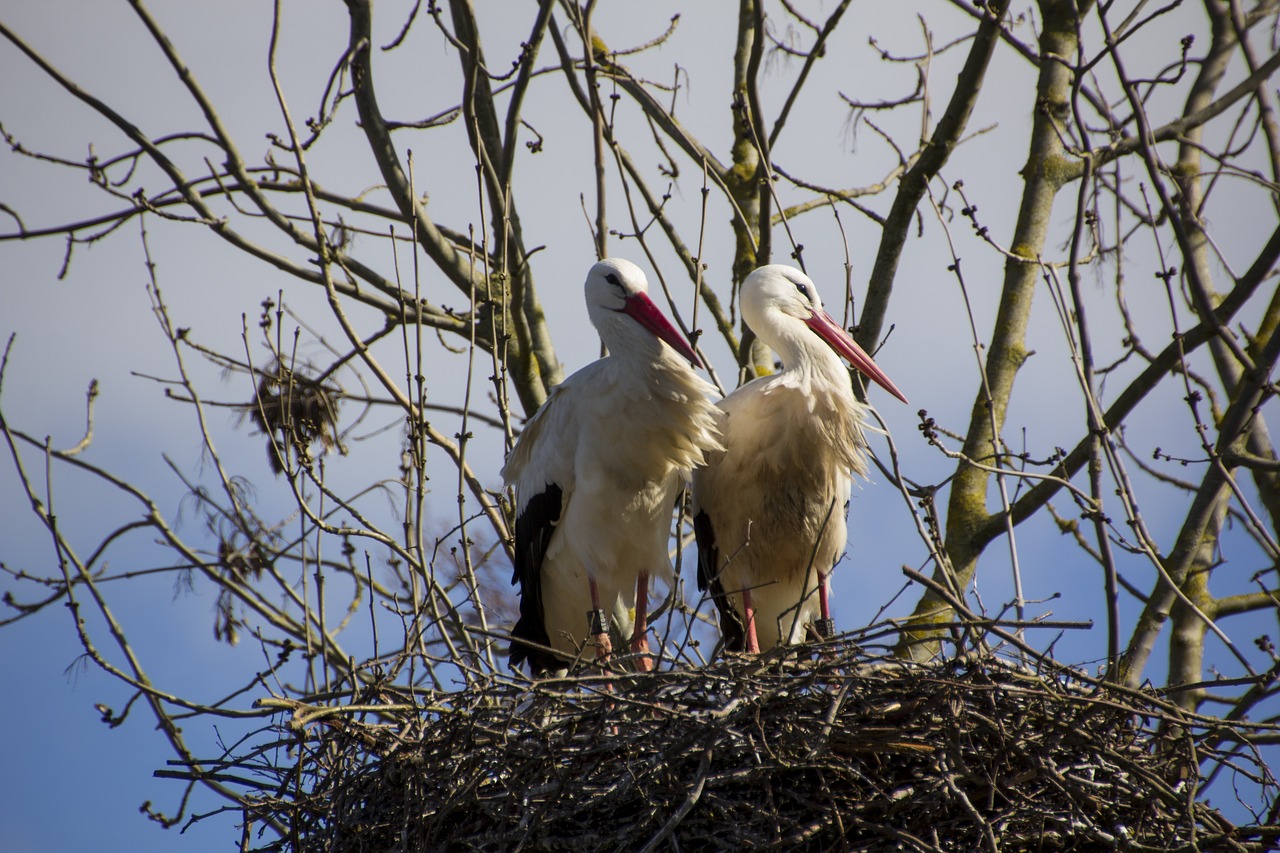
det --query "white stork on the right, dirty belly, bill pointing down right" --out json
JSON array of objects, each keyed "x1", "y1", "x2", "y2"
[{"x1": 694, "y1": 264, "x2": 906, "y2": 653}]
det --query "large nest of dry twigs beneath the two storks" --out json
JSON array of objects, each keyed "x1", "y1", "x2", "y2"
[{"x1": 232, "y1": 643, "x2": 1277, "y2": 853}]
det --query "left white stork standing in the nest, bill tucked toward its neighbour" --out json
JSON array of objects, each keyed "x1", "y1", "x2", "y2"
[{"x1": 502, "y1": 259, "x2": 722, "y2": 672}]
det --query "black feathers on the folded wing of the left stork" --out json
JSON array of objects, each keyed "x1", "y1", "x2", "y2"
[{"x1": 511, "y1": 483, "x2": 564, "y2": 674}]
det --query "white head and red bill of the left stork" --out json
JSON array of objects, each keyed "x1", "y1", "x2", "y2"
[{"x1": 585, "y1": 257, "x2": 703, "y2": 368}]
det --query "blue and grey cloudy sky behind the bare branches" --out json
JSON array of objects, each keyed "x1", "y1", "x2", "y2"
[{"x1": 0, "y1": 0, "x2": 1275, "y2": 853}]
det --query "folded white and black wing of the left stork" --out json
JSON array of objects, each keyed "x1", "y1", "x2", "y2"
[{"x1": 502, "y1": 370, "x2": 585, "y2": 672}]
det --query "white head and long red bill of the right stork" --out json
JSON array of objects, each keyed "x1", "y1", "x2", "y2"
[{"x1": 741, "y1": 264, "x2": 906, "y2": 402}]
